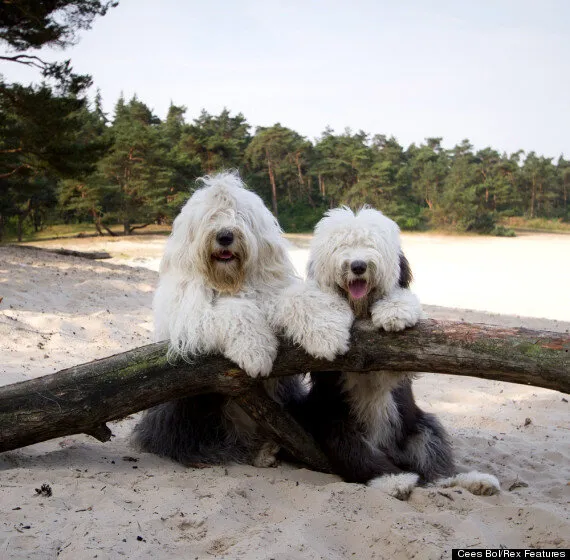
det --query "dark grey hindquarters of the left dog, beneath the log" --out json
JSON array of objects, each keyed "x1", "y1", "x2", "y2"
[{"x1": 133, "y1": 394, "x2": 263, "y2": 466}]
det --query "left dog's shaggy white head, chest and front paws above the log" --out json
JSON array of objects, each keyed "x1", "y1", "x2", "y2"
[{"x1": 153, "y1": 173, "x2": 352, "y2": 377}]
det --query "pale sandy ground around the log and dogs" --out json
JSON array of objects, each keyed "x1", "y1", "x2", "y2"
[{"x1": 0, "y1": 235, "x2": 570, "y2": 560}]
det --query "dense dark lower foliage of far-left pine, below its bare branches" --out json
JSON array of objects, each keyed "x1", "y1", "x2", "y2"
[{"x1": 0, "y1": 84, "x2": 105, "y2": 237}]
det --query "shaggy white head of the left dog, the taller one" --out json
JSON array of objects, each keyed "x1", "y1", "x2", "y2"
[{"x1": 160, "y1": 172, "x2": 289, "y2": 294}]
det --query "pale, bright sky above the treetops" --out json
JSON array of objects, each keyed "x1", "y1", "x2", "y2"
[{"x1": 0, "y1": 0, "x2": 570, "y2": 158}]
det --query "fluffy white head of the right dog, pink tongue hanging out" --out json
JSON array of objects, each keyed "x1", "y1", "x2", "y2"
[{"x1": 308, "y1": 207, "x2": 411, "y2": 317}]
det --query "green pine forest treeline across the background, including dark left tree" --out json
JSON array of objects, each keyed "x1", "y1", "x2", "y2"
[{"x1": 0, "y1": 0, "x2": 570, "y2": 240}]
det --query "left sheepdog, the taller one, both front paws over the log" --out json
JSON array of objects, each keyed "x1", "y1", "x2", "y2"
[{"x1": 134, "y1": 172, "x2": 352, "y2": 466}]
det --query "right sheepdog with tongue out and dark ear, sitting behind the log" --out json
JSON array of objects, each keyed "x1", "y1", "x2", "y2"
[{"x1": 294, "y1": 208, "x2": 499, "y2": 499}]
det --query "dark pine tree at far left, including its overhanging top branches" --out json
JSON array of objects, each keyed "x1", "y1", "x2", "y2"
[{"x1": 0, "y1": 0, "x2": 117, "y2": 240}]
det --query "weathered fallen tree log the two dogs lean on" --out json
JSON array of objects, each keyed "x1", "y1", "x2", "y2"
[{"x1": 0, "y1": 320, "x2": 570, "y2": 464}]
